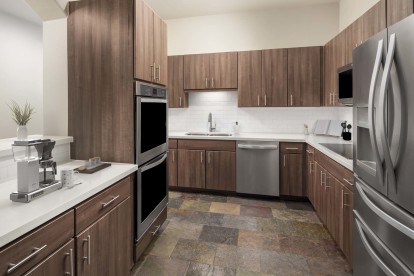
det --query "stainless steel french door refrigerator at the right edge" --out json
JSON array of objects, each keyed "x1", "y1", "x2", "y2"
[{"x1": 353, "y1": 15, "x2": 414, "y2": 275}]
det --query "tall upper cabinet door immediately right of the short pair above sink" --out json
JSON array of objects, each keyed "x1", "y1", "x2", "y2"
[{"x1": 237, "y1": 51, "x2": 263, "y2": 107}]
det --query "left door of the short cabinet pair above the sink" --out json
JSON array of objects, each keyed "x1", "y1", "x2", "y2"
[{"x1": 184, "y1": 54, "x2": 210, "y2": 90}]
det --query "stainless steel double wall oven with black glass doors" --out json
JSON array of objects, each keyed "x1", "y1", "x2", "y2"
[{"x1": 135, "y1": 81, "x2": 168, "y2": 240}]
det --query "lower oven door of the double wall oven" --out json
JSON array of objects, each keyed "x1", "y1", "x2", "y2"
[{"x1": 136, "y1": 153, "x2": 168, "y2": 240}]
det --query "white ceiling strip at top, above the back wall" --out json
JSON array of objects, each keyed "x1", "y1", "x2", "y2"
[{"x1": 146, "y1": 0, "x2": 339, "y2": 19}]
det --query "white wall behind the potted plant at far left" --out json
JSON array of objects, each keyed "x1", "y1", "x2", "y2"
[{"x1": 0, "y1": 12, "x2": 43, "y2": 138}]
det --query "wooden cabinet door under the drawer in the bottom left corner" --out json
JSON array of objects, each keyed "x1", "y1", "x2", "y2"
[{"x1": 24, "y1": 239, "x2": 75, "y2": 276}]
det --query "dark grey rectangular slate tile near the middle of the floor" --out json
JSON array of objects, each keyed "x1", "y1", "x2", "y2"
[{"x1": 199, "y1": 225, "x2": 239, "y2": 245}]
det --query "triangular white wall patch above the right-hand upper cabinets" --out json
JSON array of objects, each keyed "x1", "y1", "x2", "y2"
[{"x1": 339, "y1": 0, "x2": 379, "y2": 31}]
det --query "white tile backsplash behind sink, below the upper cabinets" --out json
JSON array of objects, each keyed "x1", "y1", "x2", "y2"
[{"x1": 169, "y1": 91, "x2": 352, "y2": 133}]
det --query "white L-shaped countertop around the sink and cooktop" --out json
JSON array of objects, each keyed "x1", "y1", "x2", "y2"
[{"x1": 168, "y1": 132, "x2": 353, "y2": 171}]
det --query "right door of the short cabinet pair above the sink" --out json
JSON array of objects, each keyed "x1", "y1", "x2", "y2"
[{"x1": 209, "y1": 52, "x2": 237, "y2": 89}]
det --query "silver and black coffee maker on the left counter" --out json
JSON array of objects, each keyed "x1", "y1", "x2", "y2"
[{"x1": 10, "y1": 139, "x2": 62, "y2": 202}]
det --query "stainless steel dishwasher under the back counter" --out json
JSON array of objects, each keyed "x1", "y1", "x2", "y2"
[{"x1": 236, "y1": 141, "x2": 279, "y2": 196}]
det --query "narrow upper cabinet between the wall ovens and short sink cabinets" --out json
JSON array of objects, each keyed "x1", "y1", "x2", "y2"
[{"x1": 167, "y1": 56, "x2": 188, "y2": 108}]
